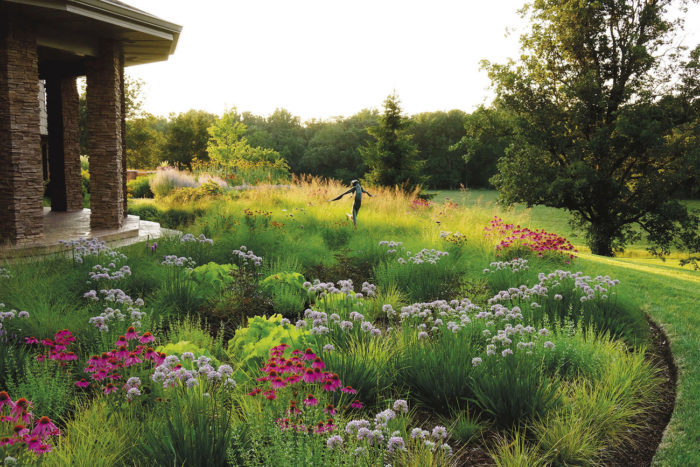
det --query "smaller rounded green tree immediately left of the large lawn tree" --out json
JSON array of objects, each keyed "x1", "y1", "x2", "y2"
[{"x1": 454, "y1": 106, "x2": 515, "y2": 188}]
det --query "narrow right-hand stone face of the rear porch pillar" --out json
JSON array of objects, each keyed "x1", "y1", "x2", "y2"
[{"x1": 61, "y1": 77, "x2": 83, "y2": 211}]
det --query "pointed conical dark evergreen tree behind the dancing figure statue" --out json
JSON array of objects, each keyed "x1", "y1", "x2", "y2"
[{"x1": 360, "y1": 93, "x2": 426, "y2": 190}]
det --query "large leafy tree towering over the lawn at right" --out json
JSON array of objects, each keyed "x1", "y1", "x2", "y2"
[{"x1": 485, "y1": 0, "x2": 698, "y2": 256}]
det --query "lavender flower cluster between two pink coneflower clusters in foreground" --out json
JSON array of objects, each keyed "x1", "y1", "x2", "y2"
[{"x1": 151, "y1": 352, "x2": 236, "y2": 389}]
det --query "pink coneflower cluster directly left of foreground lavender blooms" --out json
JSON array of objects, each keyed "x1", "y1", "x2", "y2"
[{"x1": 75, "y1": 326, "x2": 161, "y2": 394}]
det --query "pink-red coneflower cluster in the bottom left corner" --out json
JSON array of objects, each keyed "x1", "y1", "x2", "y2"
[{"x1": 0, "y1": 391, "x2": 61, "y2": 455}]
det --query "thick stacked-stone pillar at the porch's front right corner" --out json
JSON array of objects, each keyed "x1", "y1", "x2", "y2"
[{"x1": 86, "y1": 41, "x2": 124, "y2": 229}]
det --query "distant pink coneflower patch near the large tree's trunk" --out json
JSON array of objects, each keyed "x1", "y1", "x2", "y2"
[{"x1": 484, "y1": 216, "x2": 577, "y2": 259}]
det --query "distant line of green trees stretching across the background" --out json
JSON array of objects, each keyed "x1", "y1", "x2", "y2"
[{"x1": 81, "y1": 80, "x2": 512, "y2": 189}]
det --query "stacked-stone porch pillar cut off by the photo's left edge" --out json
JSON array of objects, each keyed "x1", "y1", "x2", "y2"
[{"x1": 0, "y1": 18, "x2": 44, "y2": 243}]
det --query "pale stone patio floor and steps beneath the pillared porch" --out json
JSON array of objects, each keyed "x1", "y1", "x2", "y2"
[{"x1": 0, "y1": 207, "x2": 175, "y2": 259}]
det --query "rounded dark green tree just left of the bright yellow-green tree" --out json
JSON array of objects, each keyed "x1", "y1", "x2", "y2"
[{"x1": 162, "y1": 110, "x2": 216, "y2": 170}]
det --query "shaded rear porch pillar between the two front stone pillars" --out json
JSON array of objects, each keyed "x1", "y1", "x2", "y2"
[{"x1": 46, "y1": 77, "x2": 83, "y2": 211}]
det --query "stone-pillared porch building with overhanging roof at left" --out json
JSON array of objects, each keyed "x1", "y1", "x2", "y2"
[{"x1": 0, "y1": 0, "x2": 181, "y2": 245}]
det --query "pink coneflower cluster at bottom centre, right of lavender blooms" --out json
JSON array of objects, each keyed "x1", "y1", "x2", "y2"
[{"x1": 248, "y1": 344, "x2": 362, "y2": 433}]
